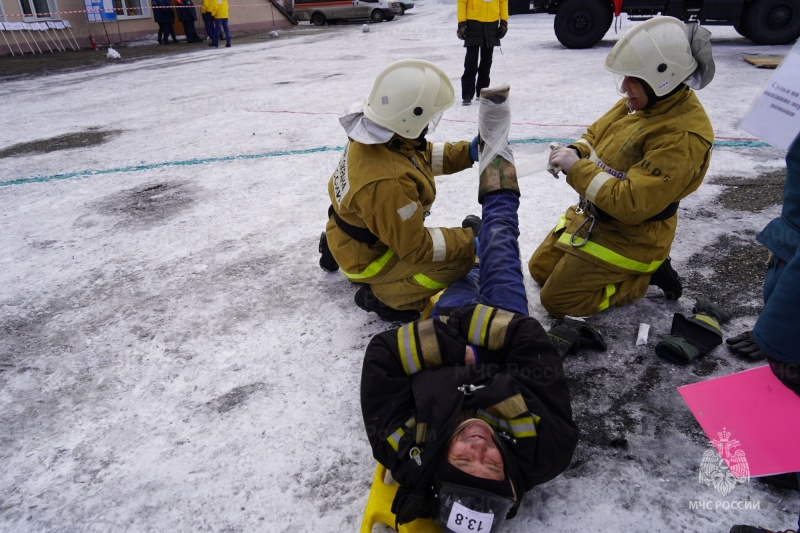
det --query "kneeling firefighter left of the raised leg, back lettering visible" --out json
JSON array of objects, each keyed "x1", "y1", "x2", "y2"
[{"x1": 320, "y1": 59, "x2": 480, "y2": 322}]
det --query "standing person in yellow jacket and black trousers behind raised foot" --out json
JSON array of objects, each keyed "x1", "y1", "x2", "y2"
[{"x1": 456, "y1": 0, "x2": 508, "y2": 105}]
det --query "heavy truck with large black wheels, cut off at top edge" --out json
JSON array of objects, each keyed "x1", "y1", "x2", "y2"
[{"x1": 509, "y1": 0, "x2": 800, "y2": 48}]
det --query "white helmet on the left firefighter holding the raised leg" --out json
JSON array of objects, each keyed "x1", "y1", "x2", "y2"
[{"x1": 363, "y1": 59, "x2": 455, "y2": 139}]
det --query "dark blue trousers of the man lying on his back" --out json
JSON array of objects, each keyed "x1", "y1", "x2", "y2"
[{"x1": 431, "y1": 192, "x2": 528, "y2": 316}]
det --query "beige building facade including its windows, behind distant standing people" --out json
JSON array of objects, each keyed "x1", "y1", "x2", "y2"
[{"x1": 0, "y1": 0, "x2": 292, "y2": 55}]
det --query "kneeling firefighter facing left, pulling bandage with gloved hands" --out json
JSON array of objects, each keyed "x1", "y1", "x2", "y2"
[{"x1": 528, "y1": 17, "x2": 714, "y2": 317}]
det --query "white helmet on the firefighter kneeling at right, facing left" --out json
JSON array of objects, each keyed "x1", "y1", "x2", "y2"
[{"x1": 605, "y1": 17, "x2": 697, "y2": 96}]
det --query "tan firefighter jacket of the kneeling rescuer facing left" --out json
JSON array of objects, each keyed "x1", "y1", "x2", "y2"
[{"x1": 558, "y1": 87, "x2": 714, "y2": 273}]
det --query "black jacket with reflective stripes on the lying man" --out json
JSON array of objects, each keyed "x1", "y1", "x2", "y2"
[{"x1": 361, "y1": 305, "x2": 578, "y2": 523}]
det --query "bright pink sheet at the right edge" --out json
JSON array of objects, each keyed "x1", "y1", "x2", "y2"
[{"x1": 678, "y1": 366, "x2": 800, "y2": 477}]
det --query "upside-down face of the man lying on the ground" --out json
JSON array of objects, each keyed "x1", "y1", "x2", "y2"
[{"x1": 447, "y1": 419, "x2": 505, "y2": 481}]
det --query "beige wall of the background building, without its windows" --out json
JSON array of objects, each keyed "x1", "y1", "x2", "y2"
[{"x1": 0, "y1": 0, "x2": 291, "y2": 56}]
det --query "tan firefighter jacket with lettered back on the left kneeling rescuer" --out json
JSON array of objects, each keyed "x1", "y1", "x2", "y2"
[{"x1": 327, "y1": 137, "x2": 475, "y2": 280}]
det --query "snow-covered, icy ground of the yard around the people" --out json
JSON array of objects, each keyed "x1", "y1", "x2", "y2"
[{"x1": 0, "y1": 0, "x2": 800, "y2": 533}]
